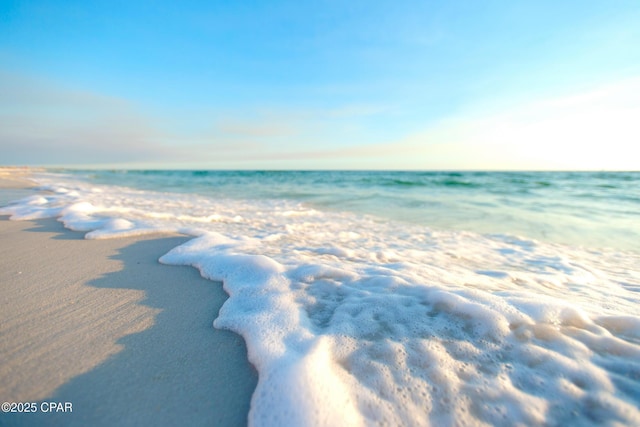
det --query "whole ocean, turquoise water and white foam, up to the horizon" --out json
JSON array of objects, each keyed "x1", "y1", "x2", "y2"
[{"x1": 0, "y1": 170, "x2": 640, "y2": 426}]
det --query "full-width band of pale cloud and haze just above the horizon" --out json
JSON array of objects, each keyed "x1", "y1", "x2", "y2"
[{"x1": 0, "y1": 69, "x2": 640, "y2": 169}]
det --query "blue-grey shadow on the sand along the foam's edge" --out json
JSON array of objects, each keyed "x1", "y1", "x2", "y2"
[{"x1": 0, "y1": 220, "x2": 257, "y2": 426}]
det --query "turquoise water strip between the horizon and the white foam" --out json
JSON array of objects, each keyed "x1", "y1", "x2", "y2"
[{"x1": 65, "y1": 171, "x2": 640, "y2": 251}]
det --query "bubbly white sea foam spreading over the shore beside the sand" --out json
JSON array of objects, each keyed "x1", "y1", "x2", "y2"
[{"x1": 0, "y1": 174, "x2": 640, "y2": 426}]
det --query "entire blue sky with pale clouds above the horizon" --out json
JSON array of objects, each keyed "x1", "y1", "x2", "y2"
[{"x1": 0, "y1": 0, "x2": 640, "y2": 170}]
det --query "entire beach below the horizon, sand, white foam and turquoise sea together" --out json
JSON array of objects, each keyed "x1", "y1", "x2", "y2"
[{"x1": 0, "y1": 169, "x2": 640, "y2": 427}]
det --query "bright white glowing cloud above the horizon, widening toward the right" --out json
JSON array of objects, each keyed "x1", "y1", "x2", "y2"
[{"x1": 240, "y1": 79, "x2": 640, "y2": 170}]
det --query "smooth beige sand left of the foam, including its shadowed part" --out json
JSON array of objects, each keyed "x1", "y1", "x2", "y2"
[{"x1": 0, "y1": 172, "x2": 257, "y2": 426}]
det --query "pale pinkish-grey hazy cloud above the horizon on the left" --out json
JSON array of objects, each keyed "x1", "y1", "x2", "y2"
[{"x1": 0, "y1": 73, "x2": 396, "y2": 168}]
